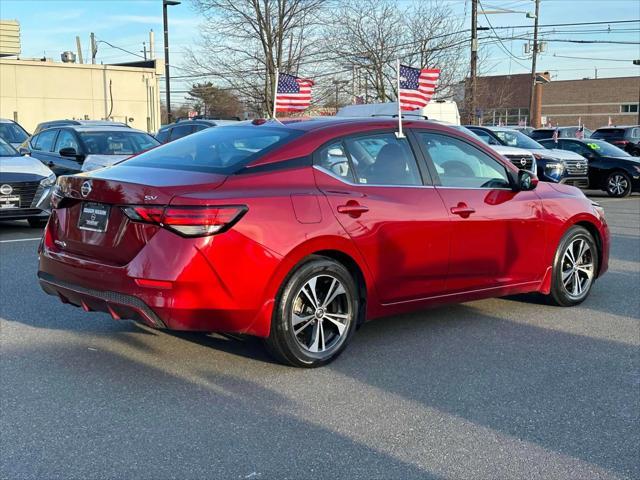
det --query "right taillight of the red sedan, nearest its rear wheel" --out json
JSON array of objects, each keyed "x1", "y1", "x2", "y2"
[{"x1": 122, "y1": 205, "x2": 248, "y2": 237}]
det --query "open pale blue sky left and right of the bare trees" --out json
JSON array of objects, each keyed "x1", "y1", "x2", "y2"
[{"x1": 0, "y1": 0, "x2": 640, "y2": 97}]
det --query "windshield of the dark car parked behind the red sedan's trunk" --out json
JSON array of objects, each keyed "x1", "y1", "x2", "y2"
[{"x1": 80, "y1": 128, "x2": 160, "y2": 155}]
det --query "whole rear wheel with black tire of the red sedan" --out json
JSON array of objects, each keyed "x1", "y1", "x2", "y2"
[{"x1": 265, "y1": 256, "x2": 360, "y2": 368}]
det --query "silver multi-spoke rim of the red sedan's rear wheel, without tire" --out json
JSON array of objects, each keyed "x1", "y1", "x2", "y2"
[{"x1": 291, "y1": 274, "x2": 353, "y2": 353}]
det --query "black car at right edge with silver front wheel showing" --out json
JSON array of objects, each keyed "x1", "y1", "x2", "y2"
[{"x1": 540, "y1": 138, "x2": 640, "y2": 197}]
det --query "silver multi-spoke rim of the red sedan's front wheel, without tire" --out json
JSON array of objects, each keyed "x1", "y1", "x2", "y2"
[{"x1": 562, "y1": 237, "x2": 595, "y2": 298}]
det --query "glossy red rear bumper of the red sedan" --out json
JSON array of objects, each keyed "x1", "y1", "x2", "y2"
[{"x1": 38, "y1": 222, "x2": 280, "y2": 337}]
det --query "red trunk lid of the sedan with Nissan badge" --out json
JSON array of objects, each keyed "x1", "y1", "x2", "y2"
[{"x1": 51, "y1": 167, "x2": 226, "y2": 266}]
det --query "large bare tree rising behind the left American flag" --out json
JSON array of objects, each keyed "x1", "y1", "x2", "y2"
[{"x1": 187, "y1": 0, "x2": 327, "y2": 114}]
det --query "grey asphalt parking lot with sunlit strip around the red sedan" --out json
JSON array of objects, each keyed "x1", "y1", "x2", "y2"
[{"x1": 0, "y1": 195, "x2": 640, "y2": 479}]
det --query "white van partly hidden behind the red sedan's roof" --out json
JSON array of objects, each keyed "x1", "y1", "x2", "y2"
[{"x1": 336, "y1": 100, "x2": 460, "y2": 125}]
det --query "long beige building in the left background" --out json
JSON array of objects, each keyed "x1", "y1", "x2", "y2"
[{"x1": 0, "y1": 58, "x2": 163, "y2": 132}]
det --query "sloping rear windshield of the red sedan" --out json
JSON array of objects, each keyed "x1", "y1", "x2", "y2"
[{"x1": 121, "y1": 125, "x2": 303, "y2": 174}]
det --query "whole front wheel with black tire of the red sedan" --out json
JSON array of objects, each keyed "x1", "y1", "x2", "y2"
[{"x1": 548, "y1": 225, "x2": 598, "y2": 307}]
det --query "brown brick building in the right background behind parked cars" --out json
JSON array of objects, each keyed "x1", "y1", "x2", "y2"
[{"x1": 464, "y1": 74, "x2": 640, "y2": 129}]
